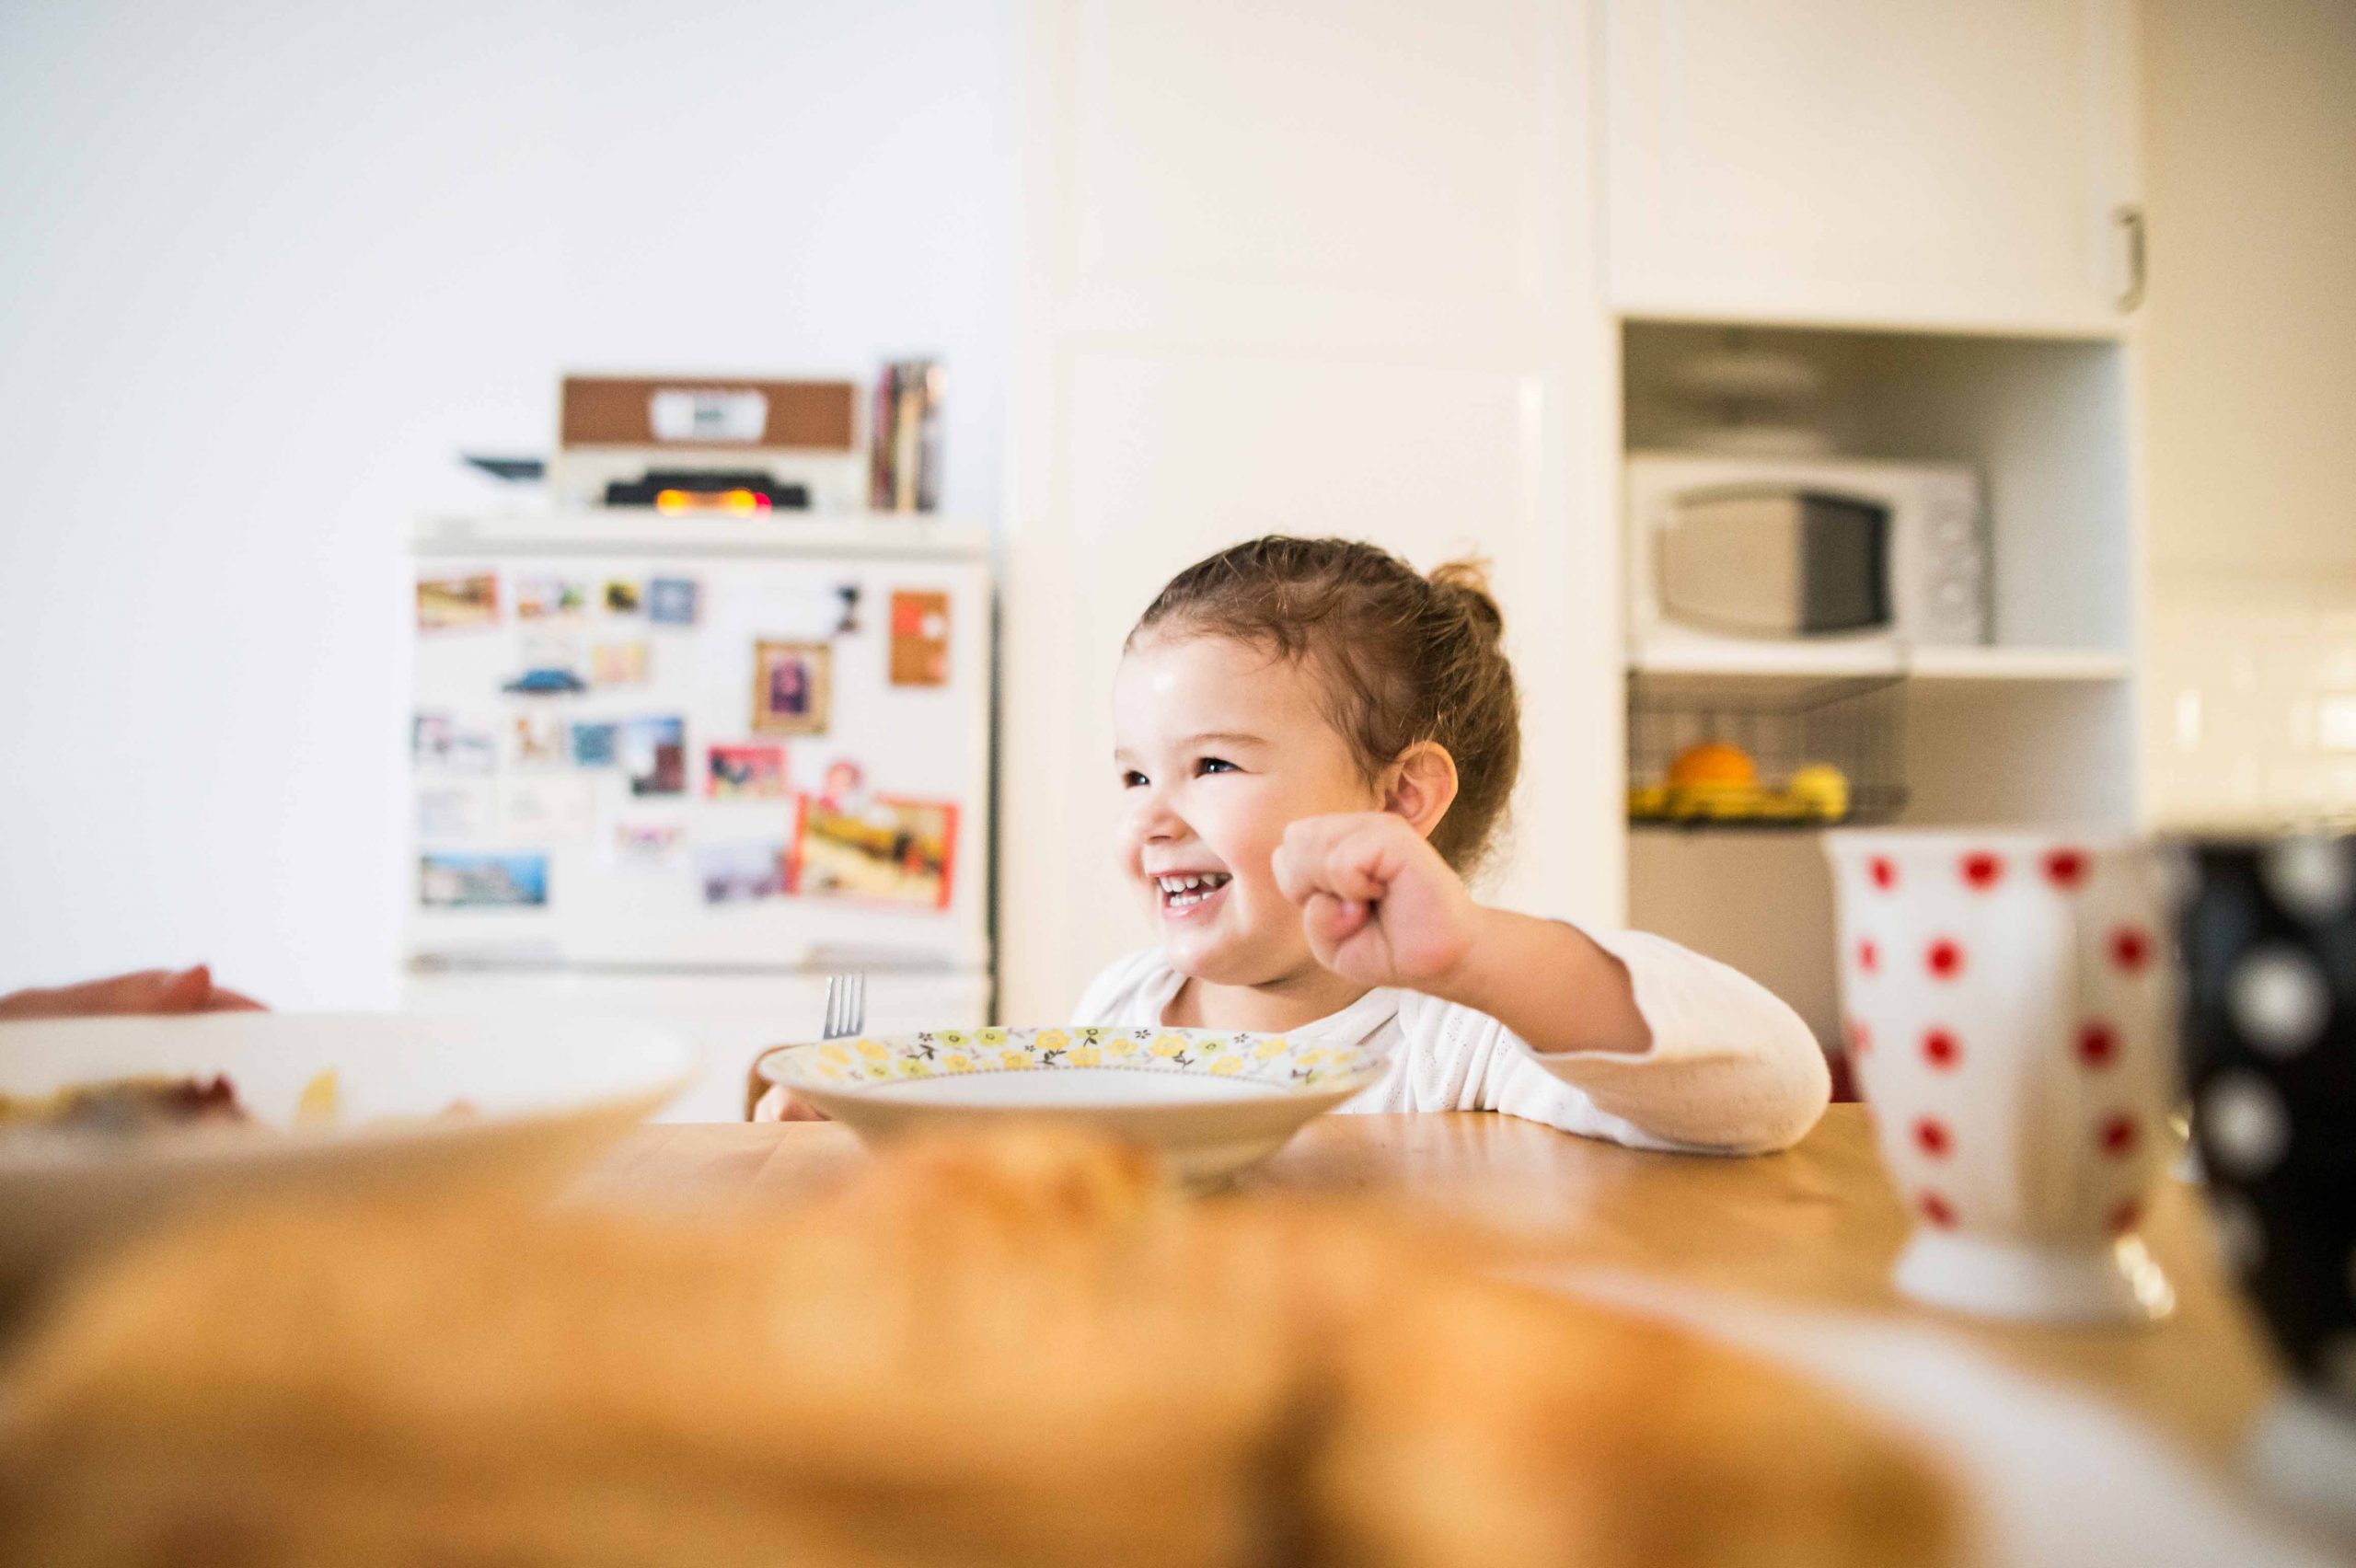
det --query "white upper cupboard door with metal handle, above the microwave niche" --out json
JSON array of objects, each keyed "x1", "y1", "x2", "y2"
[{"x1": 1604, "y1": 0, "x2": 2142, "y2": 332}]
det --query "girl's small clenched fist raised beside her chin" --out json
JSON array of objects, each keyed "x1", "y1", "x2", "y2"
[{"x1": 1272, "y1": 813, "x2": 1480, "y2": 991}]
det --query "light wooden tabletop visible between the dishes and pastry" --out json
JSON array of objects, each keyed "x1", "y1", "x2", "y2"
[{"x1": 580, "y1": 1104, "x2": 2281, "y2": 1474}]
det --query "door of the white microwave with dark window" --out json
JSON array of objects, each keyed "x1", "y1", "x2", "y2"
[{"x1": 1657, "y1": 490, "x2": 1892, "y2": 638}]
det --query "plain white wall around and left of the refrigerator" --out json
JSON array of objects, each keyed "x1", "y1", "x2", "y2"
[{"x1": 0, "y1": 0, "x2": 1013, "y2": 1006}]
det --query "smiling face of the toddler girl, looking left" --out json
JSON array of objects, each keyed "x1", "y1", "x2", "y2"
[{"x1": 1112, "y1": 633, "x2": 1380, "y2": 986}]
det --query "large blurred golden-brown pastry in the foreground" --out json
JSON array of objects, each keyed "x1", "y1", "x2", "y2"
[{"x1": 0, "y1": 1133, "x2": 1956, "y2": 1568}]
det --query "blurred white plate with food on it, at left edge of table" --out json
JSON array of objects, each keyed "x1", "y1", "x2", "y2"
[{"x1": 0, "y1": 1012, "x2": 695, "y2": 1288}]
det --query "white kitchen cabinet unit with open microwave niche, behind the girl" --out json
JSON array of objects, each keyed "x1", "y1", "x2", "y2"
[{"x1": 999, "y1": 0, "x2": 2165, "y2": 1045}]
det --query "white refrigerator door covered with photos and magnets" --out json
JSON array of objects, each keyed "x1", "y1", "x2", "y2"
[{"x1": 403, "y1": 509, "x2": 994, "y2": 1121}]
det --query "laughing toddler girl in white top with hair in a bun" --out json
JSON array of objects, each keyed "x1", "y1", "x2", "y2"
[{"x1": 761, "y1": 536, "x2": 1831, "y2": 1154}]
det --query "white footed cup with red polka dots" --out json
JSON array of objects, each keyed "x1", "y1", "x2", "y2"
[{"x1": 1826, "y1": 829, "x2": 2177, "y2": 1323}]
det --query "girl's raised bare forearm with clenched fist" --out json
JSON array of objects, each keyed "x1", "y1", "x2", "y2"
[{"x1": 1275, "y1": 813, "x2": 1652, "y2": 1055}]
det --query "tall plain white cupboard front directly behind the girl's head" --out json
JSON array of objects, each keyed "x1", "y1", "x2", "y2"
[{"x1": 999, "y1": 0, "x2": 1621, "y2": 1021}]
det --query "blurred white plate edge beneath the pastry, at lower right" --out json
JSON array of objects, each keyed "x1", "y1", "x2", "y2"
[{"x1": 1536, "y1": 1269, "x2": 2339, "y2": 1568}]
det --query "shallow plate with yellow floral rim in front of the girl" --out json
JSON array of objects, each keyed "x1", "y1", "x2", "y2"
[{"x1": 758, "y1": 1027, "x2": 1383, "y2": 1187}]
